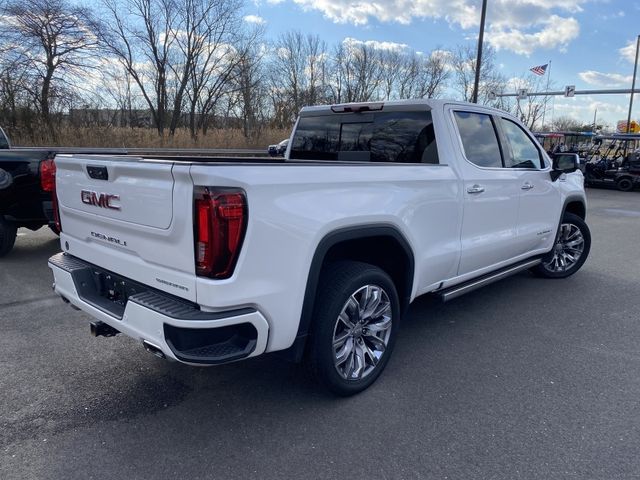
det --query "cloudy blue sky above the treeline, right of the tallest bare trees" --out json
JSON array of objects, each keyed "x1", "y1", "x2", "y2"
[{"x1": 245, "y1": 0, "x2": 640, "y2": 126}]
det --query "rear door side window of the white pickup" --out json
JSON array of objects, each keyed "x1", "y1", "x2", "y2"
[{"x1": 454, "y1": 112, "x2": 502, "y2": 168}]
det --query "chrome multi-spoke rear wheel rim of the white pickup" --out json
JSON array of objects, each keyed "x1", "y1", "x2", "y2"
[{"x1": 333, "y1": 285, "x2": 393, "y2": 380}]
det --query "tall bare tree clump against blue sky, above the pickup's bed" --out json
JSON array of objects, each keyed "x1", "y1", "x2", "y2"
[{"x1": 103, "y1": 0, "x2": 249, "y2": 138}]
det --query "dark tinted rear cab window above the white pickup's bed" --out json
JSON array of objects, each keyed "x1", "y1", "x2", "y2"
[{"x1": 289, "y1": 111, "x2": 439, "y2": 164}]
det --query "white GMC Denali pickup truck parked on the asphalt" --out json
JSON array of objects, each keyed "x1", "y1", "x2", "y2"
[{"x1": 49, "y1": 100, "x2": 591, "y2": 395}]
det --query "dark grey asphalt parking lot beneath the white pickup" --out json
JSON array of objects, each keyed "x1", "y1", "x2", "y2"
[{"x1": 0, "y1": 189, "x2": 640, "y2": 480}]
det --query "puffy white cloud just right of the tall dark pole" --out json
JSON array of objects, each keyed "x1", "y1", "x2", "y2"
[{"x1": 487, "y1": 15, "x2": 580, "y2": 55}]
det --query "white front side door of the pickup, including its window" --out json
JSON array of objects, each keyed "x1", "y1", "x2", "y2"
[{"x1": 499, "y1": 117, "x2": 564, "y2": 255}]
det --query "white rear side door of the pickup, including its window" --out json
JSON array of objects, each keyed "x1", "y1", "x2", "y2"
[{"x1": 451, "y1": 107, "x2": 520, "y2": 275}]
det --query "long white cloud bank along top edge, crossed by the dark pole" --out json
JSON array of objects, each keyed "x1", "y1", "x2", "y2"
[{"x1": 291, "y1": 0, "x2": 588, "y2": 55}]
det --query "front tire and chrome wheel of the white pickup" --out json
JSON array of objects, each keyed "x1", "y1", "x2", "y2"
[{"x1": 531, "y1": 213, "x2": 591, "y2": 278}]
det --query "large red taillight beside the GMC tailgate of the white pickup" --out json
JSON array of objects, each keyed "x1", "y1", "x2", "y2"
[{"x1": 194, "y1": 188, "x2": 247, "y2": 278}]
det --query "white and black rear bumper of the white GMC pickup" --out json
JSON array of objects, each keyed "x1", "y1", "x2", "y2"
[{"x1": 49, "y1": 253, "x2": 269, "y2": 365}]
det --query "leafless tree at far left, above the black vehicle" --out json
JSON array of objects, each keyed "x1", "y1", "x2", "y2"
[{"x1": 0, "y1": 0, "x2": 101, "y2": 136}]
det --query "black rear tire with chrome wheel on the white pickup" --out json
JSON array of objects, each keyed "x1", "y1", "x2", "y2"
[{"x1": 307, "y1": 261, "x2": 400, "y2": 396}]
